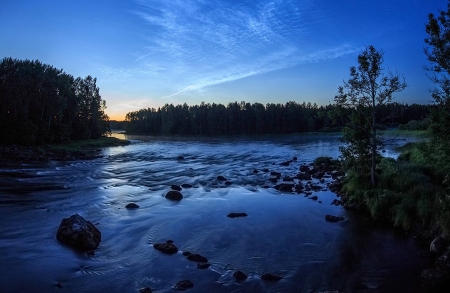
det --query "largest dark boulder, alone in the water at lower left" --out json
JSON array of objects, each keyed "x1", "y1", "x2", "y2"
[{"x1": 56, "y1": 214, "x2": 102, "y2": 250}]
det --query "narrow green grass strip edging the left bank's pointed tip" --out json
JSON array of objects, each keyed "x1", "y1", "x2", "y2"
[{"x1": 51, "y1": 136, "x2": 130, "y2": 152}]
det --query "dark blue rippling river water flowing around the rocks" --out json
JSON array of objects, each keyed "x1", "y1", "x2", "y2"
[{"x1": 0, "y1": 136, "x2": 427, "y2": 293}]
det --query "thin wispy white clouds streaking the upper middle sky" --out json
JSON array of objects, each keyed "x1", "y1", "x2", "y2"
[{"x1": 103, "y1": 0, "x2": 359, "y2": 97}]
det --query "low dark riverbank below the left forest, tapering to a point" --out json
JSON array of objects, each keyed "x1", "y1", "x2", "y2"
[{"x1": 0, "y1": 137, "x2": 130, "y2": 163}]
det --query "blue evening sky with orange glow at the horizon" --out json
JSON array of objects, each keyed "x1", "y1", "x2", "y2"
[{"x1": 0, "y1": 0, "x2": 448, "y2": 120}]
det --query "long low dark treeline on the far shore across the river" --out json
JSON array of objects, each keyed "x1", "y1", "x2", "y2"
[{"x1": 124, "y1": 102, "x2": 433, "y2": 135}]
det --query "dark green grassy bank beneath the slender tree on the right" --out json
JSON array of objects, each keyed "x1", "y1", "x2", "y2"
[{"x1": 342, "y1": 141, "x2": 450, "y2": 238}]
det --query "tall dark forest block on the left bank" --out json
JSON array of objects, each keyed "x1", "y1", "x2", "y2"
[{"x1": 0, "y1": 58, "x2": 110, "y2": 145}]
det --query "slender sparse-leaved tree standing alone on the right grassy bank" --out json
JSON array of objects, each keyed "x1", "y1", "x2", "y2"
[{"x1": 334, "y1": 46, "x2": 407, "y2": 187}]
